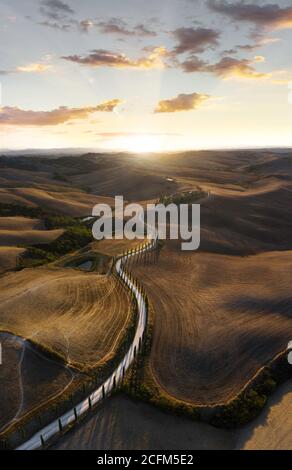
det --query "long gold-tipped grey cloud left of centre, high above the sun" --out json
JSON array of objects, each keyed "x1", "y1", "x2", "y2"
[{"x1": 62, "y1": 47, "x2": 168, "y2": 69}]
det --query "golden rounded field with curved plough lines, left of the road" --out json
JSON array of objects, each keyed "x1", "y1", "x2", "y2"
[{"x1": 0, "y1": 268, "x2": 131, "y2": 368}]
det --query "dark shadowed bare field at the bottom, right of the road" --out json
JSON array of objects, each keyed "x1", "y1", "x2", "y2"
[{"x1": 52, "y1": 396, "x2": 235, "y2": 450}]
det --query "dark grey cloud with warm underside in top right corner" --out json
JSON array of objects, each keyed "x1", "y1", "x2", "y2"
[{"x1": 208, "y1": 0, "x2": 292, "y2": 29}]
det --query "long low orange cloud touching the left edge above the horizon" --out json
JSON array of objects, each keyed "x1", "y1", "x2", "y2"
[{"x1": 0, "y1": 99, "x2": 123, "y2": 126}]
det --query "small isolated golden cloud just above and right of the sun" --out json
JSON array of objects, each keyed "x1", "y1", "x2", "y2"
[{"x1": 154, "y1": 93, "x2": 210, "y2": 113}]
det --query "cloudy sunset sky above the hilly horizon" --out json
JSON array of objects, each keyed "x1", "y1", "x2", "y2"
[{"x1": 0, "y1": 0, "x2": 292, "y2": 152}]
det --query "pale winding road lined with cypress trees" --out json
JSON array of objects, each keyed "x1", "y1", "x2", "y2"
[{"x1": 16, "y1": 239, "x2": 158, "y2": 450}]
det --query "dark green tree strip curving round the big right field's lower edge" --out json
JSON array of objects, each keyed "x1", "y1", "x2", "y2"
[{"x1": 123, "y1": 322, "x2": 292, "y2": 429}]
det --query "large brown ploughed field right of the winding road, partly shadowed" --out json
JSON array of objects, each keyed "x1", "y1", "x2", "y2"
[{"x1": 134, "y1": 250, "x2": 292, "y2": 404}]
